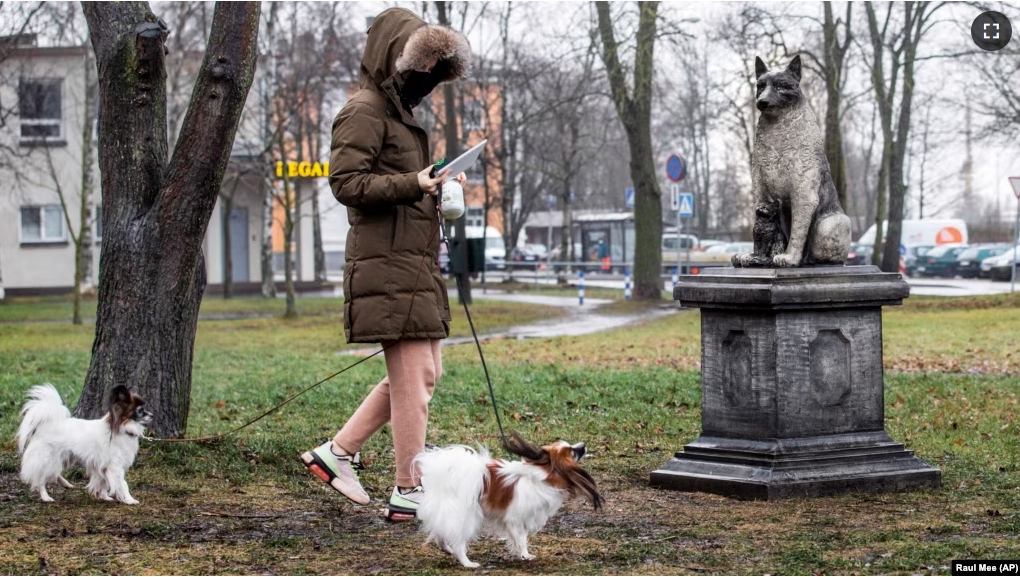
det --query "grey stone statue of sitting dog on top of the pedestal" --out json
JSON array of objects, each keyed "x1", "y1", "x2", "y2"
[{"x1": 731, "y1": 55, "x2": 851, "y2": 267}]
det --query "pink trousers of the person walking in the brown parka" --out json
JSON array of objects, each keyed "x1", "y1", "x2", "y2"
[{"x1": 334, "y1": 338, "x2": 443, "y2": 487}]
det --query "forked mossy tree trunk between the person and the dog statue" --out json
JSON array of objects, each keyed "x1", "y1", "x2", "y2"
[{"x1": 596, "y1": 2, "x2": 662, "y2": 299}]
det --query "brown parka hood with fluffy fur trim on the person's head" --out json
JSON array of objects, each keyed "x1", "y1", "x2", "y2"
[{"x1": 359, "y1": 8, "x2": 471, "y2": 89}]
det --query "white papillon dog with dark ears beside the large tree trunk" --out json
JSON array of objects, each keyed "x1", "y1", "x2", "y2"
[{"x1": 17, "y1": 384, "x2": 152, "y2": 505}]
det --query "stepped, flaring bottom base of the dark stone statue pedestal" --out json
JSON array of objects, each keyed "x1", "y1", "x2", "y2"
[{"x1": 651, "y1": 431, "x2": 941, "y2": 501}]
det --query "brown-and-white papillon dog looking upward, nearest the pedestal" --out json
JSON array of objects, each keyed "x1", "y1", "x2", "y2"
[{"x1": 414, "y1": 434, "x2": 602, "y2": 569}]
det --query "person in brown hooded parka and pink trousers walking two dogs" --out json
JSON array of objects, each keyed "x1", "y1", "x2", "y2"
[{"x1": 301, "y1": 8, "x2": 470, "y2": 520}]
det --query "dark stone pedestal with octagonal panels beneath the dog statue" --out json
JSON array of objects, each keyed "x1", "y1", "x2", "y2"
[{"x1": 651, "y1": 266, "x2": 941, "y2": 500}]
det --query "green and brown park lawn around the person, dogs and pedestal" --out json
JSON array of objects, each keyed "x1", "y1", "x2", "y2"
[{"x1": 0, "y1": 293, "x2": 1020, "y2": 575}]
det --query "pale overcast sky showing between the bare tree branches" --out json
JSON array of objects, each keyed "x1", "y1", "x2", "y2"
[{"x1": 340, "y1": 2, "x2": 1020, "y2": 217}]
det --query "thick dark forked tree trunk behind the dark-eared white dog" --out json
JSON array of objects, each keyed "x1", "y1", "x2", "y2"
[{"x1": 74, "y1": 2, "x2": 259, "y2": 437}]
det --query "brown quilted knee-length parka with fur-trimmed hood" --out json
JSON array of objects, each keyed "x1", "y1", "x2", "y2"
[{"x1": 329, "y1": 8, "x2": 470, "y2": 343}]
